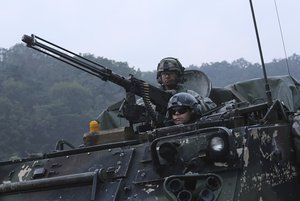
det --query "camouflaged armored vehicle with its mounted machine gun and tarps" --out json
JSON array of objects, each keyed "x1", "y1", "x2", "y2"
[{"x1": 0, "y1": 35, "x2": 300, "y2": 201}]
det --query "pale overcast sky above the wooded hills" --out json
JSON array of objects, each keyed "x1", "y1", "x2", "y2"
[{"x1": 0, "y1": 0, "x2": 300, "y2": 71}]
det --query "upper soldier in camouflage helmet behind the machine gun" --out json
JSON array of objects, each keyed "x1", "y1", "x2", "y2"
[{"x1": 156, "y1": 57, "x2": 216, "y2": 112}]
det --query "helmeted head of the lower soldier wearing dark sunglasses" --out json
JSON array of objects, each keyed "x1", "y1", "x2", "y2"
[{"x1": 167, "y1": 92, "x2": 203, "y2": 125}]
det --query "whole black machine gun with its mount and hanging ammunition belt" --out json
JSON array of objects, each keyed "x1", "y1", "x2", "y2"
[{"x1": 22, "y1": 34, "x2": 172, "y2": 126}]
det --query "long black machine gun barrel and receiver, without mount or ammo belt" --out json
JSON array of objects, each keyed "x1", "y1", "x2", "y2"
[{"x1": 22, "y1": 34, "x2": 172, "y2": 108}]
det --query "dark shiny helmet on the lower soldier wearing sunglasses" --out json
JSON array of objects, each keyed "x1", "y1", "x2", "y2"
[{"x1": 167, "y1": 92, "x2": 202, "y2": 118}]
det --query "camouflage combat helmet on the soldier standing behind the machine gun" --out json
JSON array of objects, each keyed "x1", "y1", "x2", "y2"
[{"x1": 156, "y1": 57, "x2": 184, "y2": 84}]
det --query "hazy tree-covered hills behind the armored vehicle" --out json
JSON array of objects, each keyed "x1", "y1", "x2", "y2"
[{"x1": 0, "y1": 44, "x2": 300, "y2": 160}]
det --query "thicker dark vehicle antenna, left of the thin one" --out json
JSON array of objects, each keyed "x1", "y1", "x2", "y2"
[{"x1": 249, "y1": 0, "x2": 273, "y2": 106}]
